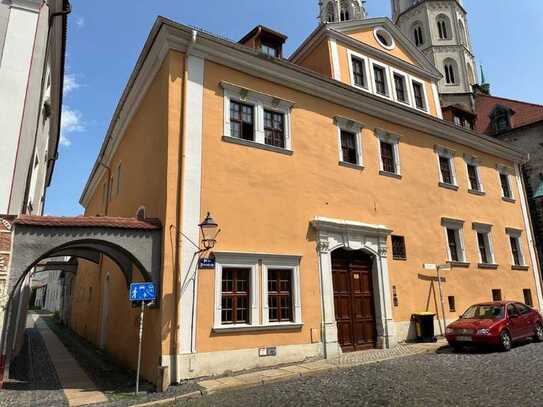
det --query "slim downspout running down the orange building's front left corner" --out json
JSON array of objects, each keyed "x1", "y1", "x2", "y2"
[{"x1": 170, "y1": 30, "x2": 198, "y2": 382}]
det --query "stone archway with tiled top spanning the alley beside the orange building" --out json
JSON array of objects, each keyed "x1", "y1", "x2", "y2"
[{"x1": 0, "y1": 216, "x2": 162, "y2": 382}]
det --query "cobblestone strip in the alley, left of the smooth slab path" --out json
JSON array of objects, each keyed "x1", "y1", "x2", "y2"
[{"x1": 0, "y1": 328, "x2": 68, "y2": 407}]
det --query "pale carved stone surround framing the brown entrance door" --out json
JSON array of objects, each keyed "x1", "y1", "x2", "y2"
[{"x1": 311, "y1": 217, "x2": 397, "y2": 358}]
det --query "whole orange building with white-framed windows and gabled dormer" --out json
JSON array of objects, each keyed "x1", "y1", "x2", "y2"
[{"x1": 70, "y1": 8, "x2": 543, "y2": 384}]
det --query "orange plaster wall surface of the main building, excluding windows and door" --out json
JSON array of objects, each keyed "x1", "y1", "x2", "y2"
[{"x1": 72, "y1": 31, "x2": 539, "y2": 380}]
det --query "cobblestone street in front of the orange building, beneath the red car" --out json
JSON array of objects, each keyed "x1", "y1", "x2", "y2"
[{"x1": 175, "y1": 343, "x2": 543, "y2": 407}]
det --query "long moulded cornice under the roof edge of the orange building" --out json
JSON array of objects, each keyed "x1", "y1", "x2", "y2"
[{"x1": 80, "y1": 17, "x2": 527, "y2": 206}]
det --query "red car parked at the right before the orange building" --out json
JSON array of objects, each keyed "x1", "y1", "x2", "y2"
[{"x1": 445, "y1": 301, "x2": 543, "y2": 351}]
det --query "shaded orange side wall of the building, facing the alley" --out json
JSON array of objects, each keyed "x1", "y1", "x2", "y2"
[{"x1": 71, "y1": 55, "x2": 177, "y2": 382}]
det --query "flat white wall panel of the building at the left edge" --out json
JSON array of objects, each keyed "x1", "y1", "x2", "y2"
[{"x1": 0, "y1": 2, "x2": 38, "y2": 214}]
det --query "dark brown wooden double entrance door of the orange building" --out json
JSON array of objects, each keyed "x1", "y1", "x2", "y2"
[{"x1": 332, "y1": 249, "x2": 377, "y2": 352}]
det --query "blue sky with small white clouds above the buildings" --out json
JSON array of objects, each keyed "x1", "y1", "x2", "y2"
[{"x1": 45, "y1": 0, "x2": 543, "y2": 215}]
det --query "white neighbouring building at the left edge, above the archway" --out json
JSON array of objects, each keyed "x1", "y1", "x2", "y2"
[{"x1": 0, "y1": 0, "x2": 70, "y2": 334}]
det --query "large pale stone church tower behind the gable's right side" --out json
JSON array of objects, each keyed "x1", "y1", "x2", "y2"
[{"x1": 391, "y1": 0, "x2": 477, "y2": 112}]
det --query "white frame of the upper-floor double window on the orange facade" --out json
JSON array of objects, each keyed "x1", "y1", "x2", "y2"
[{"x1": 221, "y1": 81, "x2": 294, "y2": 151}]
